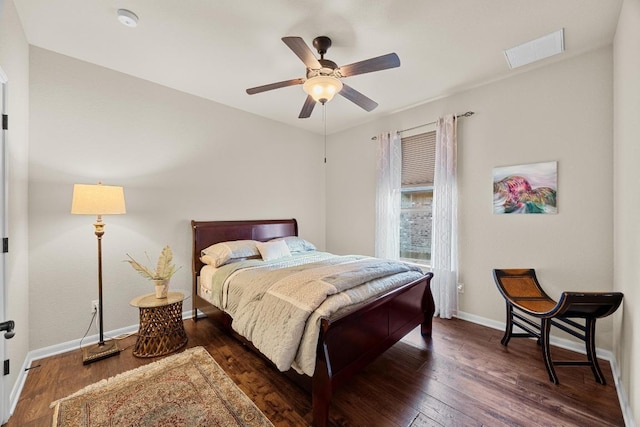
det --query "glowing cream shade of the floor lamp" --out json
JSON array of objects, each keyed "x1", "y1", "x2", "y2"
[{"x1": 71, "y1": 184, "x2": 126, "y2": 215}]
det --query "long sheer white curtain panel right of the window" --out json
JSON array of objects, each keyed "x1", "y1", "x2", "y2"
[{"x1": 431, "y1": 114, "x2": 458, "y2": 319}]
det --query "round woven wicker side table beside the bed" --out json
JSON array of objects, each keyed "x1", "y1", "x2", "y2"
[{"x1": 130, "y1": 292, "x2": 187, "y2": 357}]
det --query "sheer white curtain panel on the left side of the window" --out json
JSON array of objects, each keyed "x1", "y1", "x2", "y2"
[{"x1": 376, "y1": 132, "x2": 402, "y2": 259}]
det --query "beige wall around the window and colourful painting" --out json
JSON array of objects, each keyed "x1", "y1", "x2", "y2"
[{"x1": 327, "y1": 48, "x2": 613, "y2": 349}]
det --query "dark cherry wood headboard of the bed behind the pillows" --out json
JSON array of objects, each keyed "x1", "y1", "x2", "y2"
[{"x1": 191, "y1": 219, "x2": 298, "y2": 278}]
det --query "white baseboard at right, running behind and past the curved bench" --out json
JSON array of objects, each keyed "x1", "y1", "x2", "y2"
[{"x1": 456, "y1": 311, "x2": 635, "y2": 427}]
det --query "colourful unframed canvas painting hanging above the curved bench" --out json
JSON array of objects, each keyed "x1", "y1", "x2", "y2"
[{"x1": 493, "y1": 162, "x2": 558, "y2": 214}]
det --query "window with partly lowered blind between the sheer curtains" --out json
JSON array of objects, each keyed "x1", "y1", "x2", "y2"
[{"x1": 400, "y1": 131, "x2": 436, "y2": 264}]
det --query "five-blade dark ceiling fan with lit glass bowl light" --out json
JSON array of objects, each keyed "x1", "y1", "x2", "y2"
[{"x1": 247, "y1": 36, "x2": 400, "y2": 119}]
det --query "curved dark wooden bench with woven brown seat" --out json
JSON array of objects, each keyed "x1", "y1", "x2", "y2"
[{"x1": 493, "y1": 269, "x2": 623, "y2": 384}]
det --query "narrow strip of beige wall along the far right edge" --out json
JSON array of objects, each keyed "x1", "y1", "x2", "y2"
[{"x1": 613, "y1": 0, "x2": 640, "y2": 425}]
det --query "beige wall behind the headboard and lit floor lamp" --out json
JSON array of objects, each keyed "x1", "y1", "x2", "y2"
[{"x1": 29, "y1": 47, "x2": 325, "y2": 349}]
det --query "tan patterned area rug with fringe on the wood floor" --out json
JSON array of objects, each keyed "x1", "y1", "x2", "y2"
[{"x1": 51, "y1": 347, "x2": 273, "y2": 427}]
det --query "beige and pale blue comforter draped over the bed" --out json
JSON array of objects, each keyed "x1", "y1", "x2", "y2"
[{"x1": 200, "y1": 252, "x2": 423, "y2": 376}]
